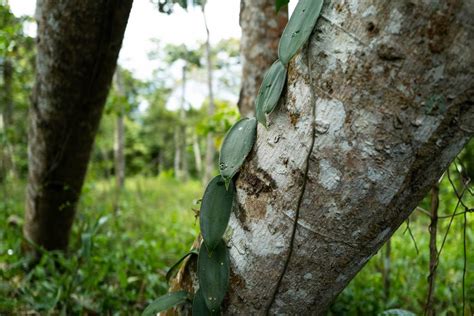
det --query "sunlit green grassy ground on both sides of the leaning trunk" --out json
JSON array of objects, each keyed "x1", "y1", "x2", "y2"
[{"x1": 0, "y1": 172, "x2": 474, "y2": 315}]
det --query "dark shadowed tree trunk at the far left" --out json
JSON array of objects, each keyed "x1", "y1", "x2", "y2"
[{"x1": 24, "y1": 0, "x2": 132, "y2": 249}]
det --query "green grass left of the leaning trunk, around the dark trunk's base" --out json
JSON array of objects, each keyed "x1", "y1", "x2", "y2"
[{"x1": 0, "y1": 174, "x2": 202, "y2": 315}]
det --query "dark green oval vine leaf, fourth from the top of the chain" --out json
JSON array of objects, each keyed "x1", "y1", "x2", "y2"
[{"x1": 199, "y1": 176, "x2": 235, "y2": 251}]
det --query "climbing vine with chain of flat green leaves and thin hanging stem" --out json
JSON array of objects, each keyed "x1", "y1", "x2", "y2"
[{"x1": 143, "y1": 0, "x2": 323, "y2": 316}]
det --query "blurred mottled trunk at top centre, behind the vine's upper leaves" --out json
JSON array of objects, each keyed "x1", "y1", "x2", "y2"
[{"x1": 238, "y1": 0, "x2": 288, "y2": 116}]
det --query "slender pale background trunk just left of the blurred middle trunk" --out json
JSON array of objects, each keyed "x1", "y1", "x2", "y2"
[{"x1": 201, "y1": 4, "x2": 216, "y2": 184}]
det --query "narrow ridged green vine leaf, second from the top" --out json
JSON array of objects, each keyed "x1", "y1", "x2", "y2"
[{"x1": 255, "y1": 60, "x2": 286, "y2": 127}]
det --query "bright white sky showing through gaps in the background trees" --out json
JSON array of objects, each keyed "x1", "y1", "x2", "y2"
[{"x1": 10, "y1": 0, "x2": 295, "y2": 109}]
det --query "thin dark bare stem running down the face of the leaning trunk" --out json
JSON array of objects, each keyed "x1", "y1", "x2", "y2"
[{"x1": 265, "y1": 45, "x2": 316, "y2": 315}]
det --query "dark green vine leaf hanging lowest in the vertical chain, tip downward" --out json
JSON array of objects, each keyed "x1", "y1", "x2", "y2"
[{"x1": 198, "y1": 240, "x2": 230, "y2": 312}]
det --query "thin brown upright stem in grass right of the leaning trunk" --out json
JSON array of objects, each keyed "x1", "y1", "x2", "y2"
[{"x1": 425, "y1": 184, "x2": 439, "y2": 316}]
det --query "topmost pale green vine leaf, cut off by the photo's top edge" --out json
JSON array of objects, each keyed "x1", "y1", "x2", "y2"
[{"x1": 278, "y1": 0, "x2": 324, "y2": 65}]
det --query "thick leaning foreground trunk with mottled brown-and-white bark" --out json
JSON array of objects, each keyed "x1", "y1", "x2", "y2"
[{"x1": 174, "y1": 0, "x2": 474, "y2": 315}]
